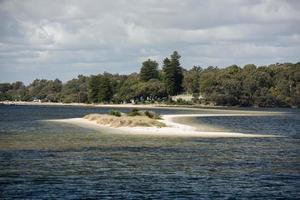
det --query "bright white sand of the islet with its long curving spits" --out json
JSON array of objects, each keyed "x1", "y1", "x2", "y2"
[{"x1": 48, "y1": 113, "x2": 280, "y2": 138}]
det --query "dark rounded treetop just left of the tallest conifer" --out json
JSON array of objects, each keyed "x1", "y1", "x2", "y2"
[{"x1": 140, "y1": 59, "x2": 158, "y2": 81}]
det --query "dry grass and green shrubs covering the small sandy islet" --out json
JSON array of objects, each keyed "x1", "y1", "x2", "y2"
[{"x1": 83, "y1": 110, "x2": 166, "y2": 128}]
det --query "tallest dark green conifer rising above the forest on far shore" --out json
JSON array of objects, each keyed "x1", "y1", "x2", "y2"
[{"x1": 163, "y1": 51, "x2": 183, "y2": 95}]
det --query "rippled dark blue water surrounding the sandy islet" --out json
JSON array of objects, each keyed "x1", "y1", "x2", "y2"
[{"x1": 0, "y1": 106, "x2": 300, "y2": 199}]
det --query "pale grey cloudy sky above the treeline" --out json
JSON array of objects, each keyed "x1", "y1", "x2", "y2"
[{"x1": 0, "y1": 0, "x2": 300, "y2": 84}]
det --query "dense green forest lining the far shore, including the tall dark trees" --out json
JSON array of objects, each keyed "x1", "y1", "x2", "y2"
[{"x1": 0, "y1": 51, "x2": 300, "y2": 107}]
